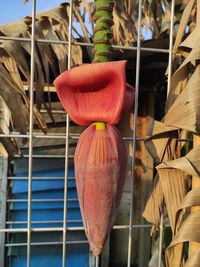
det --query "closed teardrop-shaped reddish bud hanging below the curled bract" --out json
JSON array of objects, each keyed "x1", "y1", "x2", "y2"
[{"x1": 75, "y1": 124, "x2": 126, "y2": 256}]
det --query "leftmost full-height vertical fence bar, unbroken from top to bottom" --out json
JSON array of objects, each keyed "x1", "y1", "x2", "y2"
[{"x1": 27, "y1": 0, "x2": 36, "y2": 267}]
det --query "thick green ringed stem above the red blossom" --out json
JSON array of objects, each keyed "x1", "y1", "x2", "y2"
[{"x1": 93, "y1": 0, "x2": 113, "y2": 62}]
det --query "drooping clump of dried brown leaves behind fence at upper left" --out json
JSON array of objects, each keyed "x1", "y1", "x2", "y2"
[{"x1": 0, "y1": 4, "x2": 82, "y2": 137}]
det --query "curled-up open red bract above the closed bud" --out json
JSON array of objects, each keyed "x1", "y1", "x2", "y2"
[{"x1": 54, "y1": 61, "x2": 134, "y2": 126}]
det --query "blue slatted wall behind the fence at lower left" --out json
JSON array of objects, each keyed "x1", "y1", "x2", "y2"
[{"x1": 8, "y1": 163, "x2": 89, "y2": 267}]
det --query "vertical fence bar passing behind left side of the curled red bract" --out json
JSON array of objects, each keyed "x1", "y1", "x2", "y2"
[{"x1": 62, "y1": 0, "x2": 73, "y2": 267}]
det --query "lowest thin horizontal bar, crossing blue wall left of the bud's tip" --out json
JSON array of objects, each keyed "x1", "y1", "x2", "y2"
[{"x1": 5, "y1": 240, "x2": 88, "y2": 247}]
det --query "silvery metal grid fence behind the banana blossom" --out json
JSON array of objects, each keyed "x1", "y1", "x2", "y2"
[{"x1": 0, "y1": 0, "x2": 175, "y2": 267}]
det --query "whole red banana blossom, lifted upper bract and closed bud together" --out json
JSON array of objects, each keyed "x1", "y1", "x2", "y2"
[{"x1": 54, "y1": 61, "x2": 134, "y2": 256}]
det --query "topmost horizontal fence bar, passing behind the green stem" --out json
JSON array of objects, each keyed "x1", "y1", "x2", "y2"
[{"x1": 0, "y1": 36, "x2": 169, "y2": 54}]
